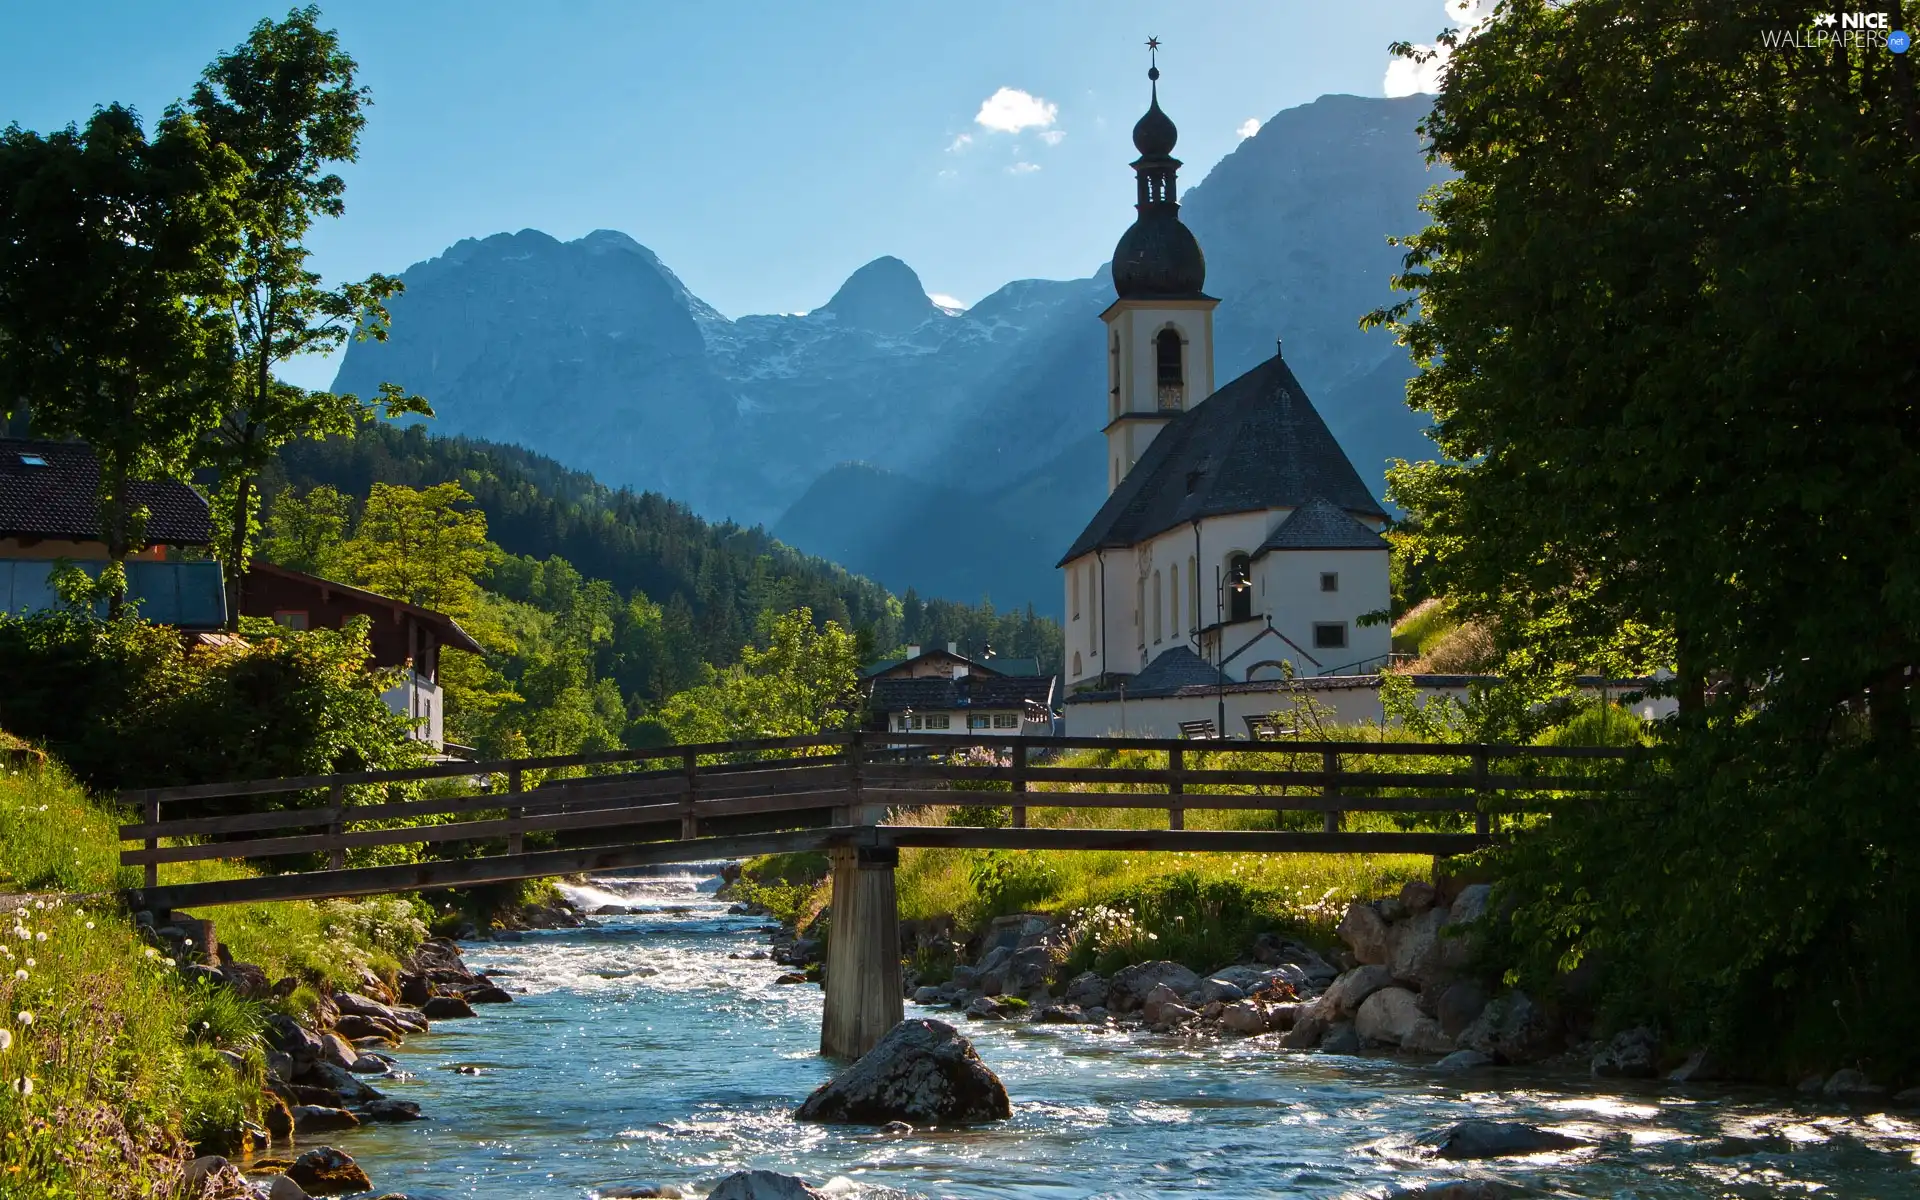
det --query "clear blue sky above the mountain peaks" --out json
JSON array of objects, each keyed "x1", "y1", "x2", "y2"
[{"x1": 0, "y1": 0, "x2": 1448, "y2": 384}]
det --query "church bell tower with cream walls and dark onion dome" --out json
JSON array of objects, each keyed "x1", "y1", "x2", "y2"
[{"x1": 1100, "y1": 38, "x2": 1219, "y2": 493}]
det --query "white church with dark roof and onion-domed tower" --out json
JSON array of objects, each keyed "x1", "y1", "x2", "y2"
[{"x1": 1058, "y1": 58, "x2": 1392, "y2": 737}]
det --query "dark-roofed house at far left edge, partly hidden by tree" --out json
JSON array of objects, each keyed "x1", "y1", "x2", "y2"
[{"x1": 0, "y1": 438, "x2": 227, "y2": 632}]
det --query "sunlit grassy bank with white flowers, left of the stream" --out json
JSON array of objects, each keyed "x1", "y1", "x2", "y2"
[{"x1": 0, "y1": 752, "x2": 426, "y2": 1200}]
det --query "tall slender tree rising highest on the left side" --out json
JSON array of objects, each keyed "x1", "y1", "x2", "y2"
[{"x1": 192, "y1": 6, "x2": 432, "y2": 620}]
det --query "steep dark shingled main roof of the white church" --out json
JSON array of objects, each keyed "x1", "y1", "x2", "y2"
[{"x1": 1058, "y1": 355, "x2": 1386, "y2": 566}]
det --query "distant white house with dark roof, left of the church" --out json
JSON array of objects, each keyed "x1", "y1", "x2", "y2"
[{"x1": 866, "y1": 641, "x2": 1060, "y2": 735}]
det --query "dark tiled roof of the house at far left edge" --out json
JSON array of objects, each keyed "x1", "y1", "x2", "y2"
[{"x1": 0, "y1": 438, "x2": 213, "y2": 545}]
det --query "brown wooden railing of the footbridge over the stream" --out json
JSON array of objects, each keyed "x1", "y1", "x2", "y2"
[{"x1": 121, "y1": 732, "x2": 1645, "y2": 889}]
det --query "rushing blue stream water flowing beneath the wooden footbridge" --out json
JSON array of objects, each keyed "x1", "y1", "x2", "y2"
[{"x1": 336, "y1": 874, "x2": 1920, "y2": 1200}]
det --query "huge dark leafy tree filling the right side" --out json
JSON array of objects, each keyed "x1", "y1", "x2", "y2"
[{"x1": 1382, "y1": 0, "x2": 1920, "y2": 1077}]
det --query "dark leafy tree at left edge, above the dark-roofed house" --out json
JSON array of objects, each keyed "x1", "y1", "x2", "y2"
[{"x1": 0, "y1": 106, "x2": 244, "y2": 611}]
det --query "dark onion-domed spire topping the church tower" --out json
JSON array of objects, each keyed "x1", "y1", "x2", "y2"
[{"x1": 1114, "y1": 38, "x2": 1206, "y2": 300}]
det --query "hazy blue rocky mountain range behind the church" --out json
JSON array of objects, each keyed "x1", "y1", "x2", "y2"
[{"x1": 334, "y1": 96, "x2": 1442, "y2": 612}]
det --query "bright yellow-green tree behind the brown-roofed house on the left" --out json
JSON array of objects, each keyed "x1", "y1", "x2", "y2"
[{"x1": 340, "y1": 484, "x2": 499, "y2": 620}]
